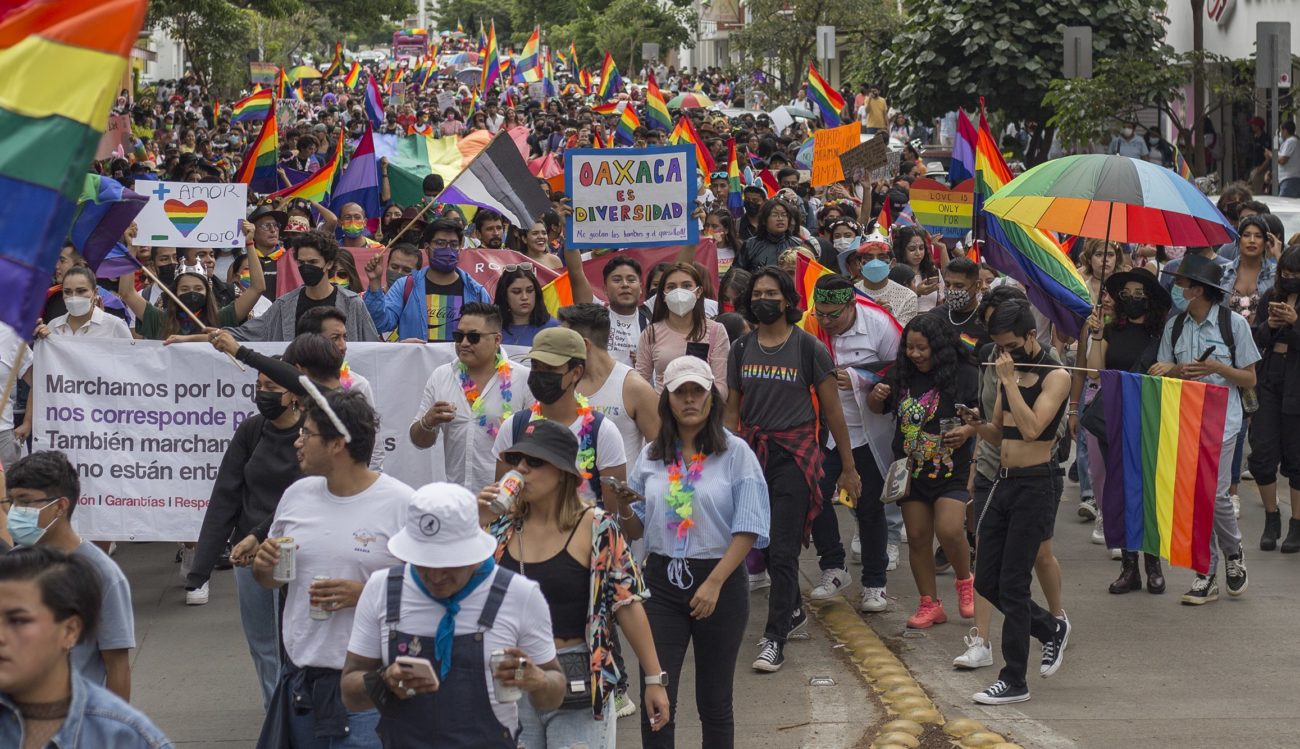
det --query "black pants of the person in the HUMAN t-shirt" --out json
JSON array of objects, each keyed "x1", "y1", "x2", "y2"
[{"x1": 763, "y1": 445, "x2": 811, "y2": 642}]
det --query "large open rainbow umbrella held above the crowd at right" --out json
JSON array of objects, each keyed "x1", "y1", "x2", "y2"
[{"x1": 984, "y1": 153, "x2": 1236, "y2": 247}]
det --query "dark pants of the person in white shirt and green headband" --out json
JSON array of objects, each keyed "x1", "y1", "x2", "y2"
[{"x1": 813, "y1": 445, "x2": 889, "y2": 588}]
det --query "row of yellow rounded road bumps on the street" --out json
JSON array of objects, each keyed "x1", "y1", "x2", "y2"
[{"x1": 809, "y1": 598, "x2": 1022, "y2": 749}]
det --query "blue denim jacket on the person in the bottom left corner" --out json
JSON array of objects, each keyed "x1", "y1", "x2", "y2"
[{"x1": 0, "y1": 671, "x2": 172, "y2": 749}]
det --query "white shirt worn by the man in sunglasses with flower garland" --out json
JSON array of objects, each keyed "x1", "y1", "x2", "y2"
[{"x1": 415, "y1": 361, "x2": 534, "y2": 494}]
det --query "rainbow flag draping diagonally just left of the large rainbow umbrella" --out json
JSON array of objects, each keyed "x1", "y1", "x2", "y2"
[{"x1": 972, "y1": 101, "x2": 1092, "y2": 338}]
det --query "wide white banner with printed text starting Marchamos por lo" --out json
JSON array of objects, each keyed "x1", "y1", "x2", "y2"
[{"x1": 33, "y1": 335, "x2": 527, "y2": 541}]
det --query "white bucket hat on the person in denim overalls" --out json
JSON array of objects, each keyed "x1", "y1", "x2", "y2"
[{"x1": 389, "y1": 484, "x2": 497, "y2": 568}]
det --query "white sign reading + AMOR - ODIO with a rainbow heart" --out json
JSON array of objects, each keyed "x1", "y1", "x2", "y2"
[{"x1": 135, "y1": 182, "x2": 248, "y2": 247}]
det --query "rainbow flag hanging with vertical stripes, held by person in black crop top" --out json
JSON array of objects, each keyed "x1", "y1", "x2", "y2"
[{"x1": 1099, "y1": 369, "x2": 1229, "y2": 575}]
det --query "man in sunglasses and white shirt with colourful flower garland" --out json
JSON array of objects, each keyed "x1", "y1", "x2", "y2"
[{"x1": 407, "y1": 302, "x2": 533, "y2": 493}]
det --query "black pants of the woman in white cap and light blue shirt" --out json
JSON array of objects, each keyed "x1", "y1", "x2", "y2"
[{"x1": 637, "y1": 554, "x2": 749, "y2": 749}]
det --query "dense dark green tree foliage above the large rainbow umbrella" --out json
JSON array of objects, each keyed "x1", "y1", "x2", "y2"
[{"x1": 881, "y1": 0, "x2": 1166, "y2": 122}]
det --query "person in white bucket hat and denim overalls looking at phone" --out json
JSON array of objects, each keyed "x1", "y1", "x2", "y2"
[{"x1": 342, "y1": 484, "x2": 564, "y2": 749}]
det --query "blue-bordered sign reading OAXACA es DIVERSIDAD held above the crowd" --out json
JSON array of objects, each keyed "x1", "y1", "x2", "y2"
[{"x1": 564, "y1": 146, "x2": 699, "y2": 250}]
